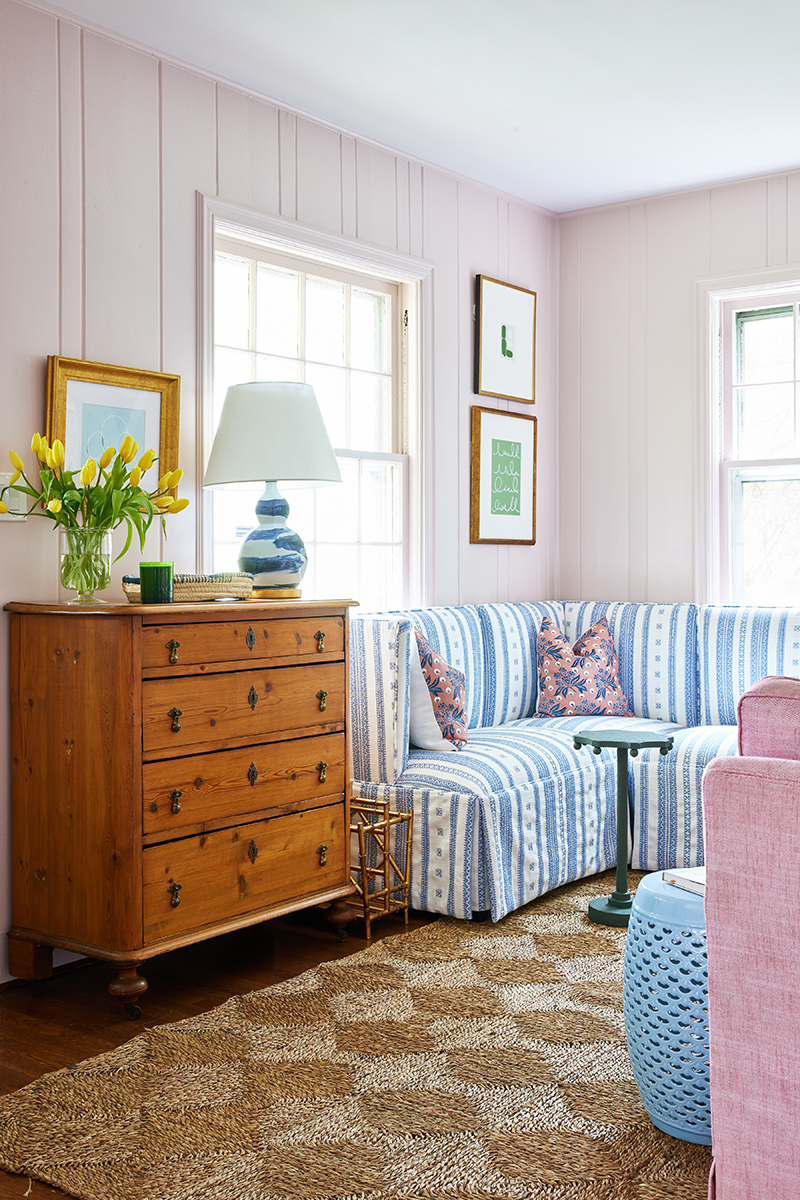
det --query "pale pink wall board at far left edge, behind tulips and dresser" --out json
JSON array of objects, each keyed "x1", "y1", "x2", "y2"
[{"x1": 0, "y1": 0, "x2": 59, "y2": 978}]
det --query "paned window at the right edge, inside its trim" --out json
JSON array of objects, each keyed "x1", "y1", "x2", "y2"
[{"x1": 720, "y1": 293, "x2": 800, "y2": 605}]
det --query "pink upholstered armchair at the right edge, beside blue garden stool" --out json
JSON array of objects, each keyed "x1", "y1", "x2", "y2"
[{"x1": 703, "y1": 677, "x2": 800, "y2": 1200}]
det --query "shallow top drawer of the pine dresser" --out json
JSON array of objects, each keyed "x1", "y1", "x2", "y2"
[{"x1": 142, "y1": 617, "x2": 344, "y2": 674}]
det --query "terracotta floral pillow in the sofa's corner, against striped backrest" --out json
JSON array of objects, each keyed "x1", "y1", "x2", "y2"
[{"x1": 536, "y1": 617, "x2": 633, "y2": 716}]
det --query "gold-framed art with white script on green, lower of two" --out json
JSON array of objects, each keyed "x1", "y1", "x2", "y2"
[{"x1": 469, "y1": 404, "x2": 536, "y2": 546}]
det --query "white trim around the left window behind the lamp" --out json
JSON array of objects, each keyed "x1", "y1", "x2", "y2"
[{"x1": 196, "y1": 192, "x2": 433, "y2": 606}]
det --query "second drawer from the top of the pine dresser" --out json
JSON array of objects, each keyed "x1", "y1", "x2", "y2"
[{"x1": 142, "y1": 662, "x2": 344, "y2": 754}]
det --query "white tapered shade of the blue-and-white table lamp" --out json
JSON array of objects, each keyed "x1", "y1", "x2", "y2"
[{"x1": 203, "y1": 383, "x2": 342, "y2": 487}]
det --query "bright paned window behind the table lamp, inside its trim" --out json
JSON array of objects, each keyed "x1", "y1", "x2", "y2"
[{"x1": 211, "y1": 236, "x2": 408, "y2": 610}]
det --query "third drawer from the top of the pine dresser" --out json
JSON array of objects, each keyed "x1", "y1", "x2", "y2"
[{"x1": 143, "y1": 733, "x2": 344, "y2": 836}]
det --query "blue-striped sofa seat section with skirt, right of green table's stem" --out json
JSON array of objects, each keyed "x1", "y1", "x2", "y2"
[{"x1": 628, "y1": 725, "x2": 736, "y2": 871}]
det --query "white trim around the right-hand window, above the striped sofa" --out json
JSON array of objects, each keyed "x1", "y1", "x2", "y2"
[{"x1": 694, "y1": 263, "x2": 800, "y2": 604}]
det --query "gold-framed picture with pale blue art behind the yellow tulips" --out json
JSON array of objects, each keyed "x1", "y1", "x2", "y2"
[{"x1": 44, "y1": 354, "x2": 181, "y2": 476}]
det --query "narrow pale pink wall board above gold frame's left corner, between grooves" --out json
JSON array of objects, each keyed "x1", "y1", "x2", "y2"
[{"x1": 59, "y1": 20, "x2": 84, "y2": 359}]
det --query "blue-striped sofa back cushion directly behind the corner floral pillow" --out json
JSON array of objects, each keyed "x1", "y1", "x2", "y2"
[{"x1": 564, "y1": 601, "x2": 698, "y2": 725}]
